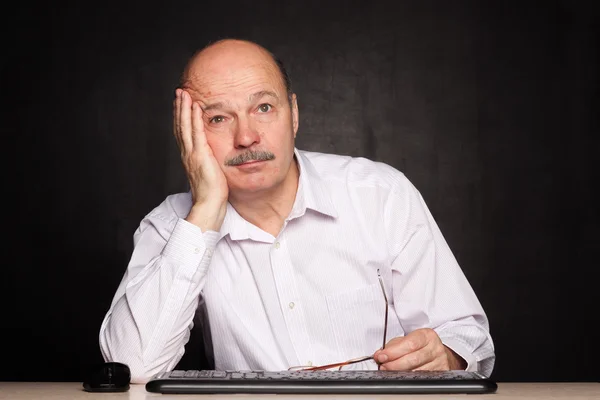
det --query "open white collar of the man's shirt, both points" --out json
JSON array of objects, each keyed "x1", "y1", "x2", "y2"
[{"x1": 219, "y1": 148, "x2": 338, "y2": 239}]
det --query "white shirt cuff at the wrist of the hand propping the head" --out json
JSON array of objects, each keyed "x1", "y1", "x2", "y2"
[{"x1": 163, "y1": 218, "x2": 219, "y2": 266}]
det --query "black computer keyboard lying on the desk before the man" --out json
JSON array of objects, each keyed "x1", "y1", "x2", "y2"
[{"x1": 146, "y1": 370, "x2": 497, "y2": 394}]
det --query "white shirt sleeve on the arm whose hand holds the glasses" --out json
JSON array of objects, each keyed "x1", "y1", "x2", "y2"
[{"x1": 385, "y1": 175, "x2": 495, "y2": 376}]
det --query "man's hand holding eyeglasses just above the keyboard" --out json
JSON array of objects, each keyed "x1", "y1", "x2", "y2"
[{"x1": 373, "y1": 328, "x2": 467, "y2": 371}]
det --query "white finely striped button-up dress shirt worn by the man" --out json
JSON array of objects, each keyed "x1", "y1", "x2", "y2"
[{"x1": 100, "y1": 149, "x2": 495, "y2": 382}]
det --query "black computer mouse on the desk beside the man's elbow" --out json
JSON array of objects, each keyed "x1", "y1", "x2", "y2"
[{"x1": 83, "y1": 362, "x2": 131, "y2": 392}]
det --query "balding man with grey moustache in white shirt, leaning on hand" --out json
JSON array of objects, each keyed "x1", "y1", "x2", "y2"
[{"x1": 100, "y1": 40, "x2": 495, "y2": 383}]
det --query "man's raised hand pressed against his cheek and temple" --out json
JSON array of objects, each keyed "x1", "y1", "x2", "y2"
[{"x1": 173, "y1": 88, "x2": 229, "y2": 232}]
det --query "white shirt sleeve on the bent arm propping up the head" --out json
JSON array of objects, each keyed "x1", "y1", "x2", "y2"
[{"x1": 100, "y1": 214, "x2": 219, "y2": 383}]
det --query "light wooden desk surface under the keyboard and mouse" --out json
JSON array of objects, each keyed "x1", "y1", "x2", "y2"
[{"x1": 0, "y1": 382, "x2": 600, "y2": 400}]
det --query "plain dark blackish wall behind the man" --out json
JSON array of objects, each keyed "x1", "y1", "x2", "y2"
[{"x1": 0, "y1": 0, "x2": 600, "y2": 381}]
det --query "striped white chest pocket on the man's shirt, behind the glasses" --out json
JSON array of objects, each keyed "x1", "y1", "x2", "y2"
[{"x1": 326, "y1": 283, "x2": 386, "y2": 359}]
